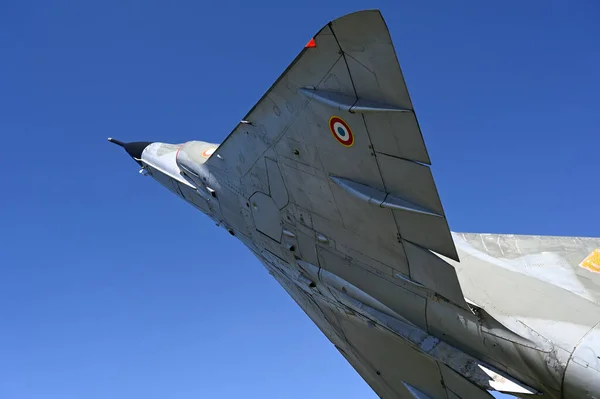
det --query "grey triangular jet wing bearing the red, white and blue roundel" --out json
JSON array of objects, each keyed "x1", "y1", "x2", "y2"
[{"x1": 207, "y1": 11, "x2": 482, "y2": 397}]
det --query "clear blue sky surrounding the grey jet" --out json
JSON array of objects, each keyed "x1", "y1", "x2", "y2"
[{"x1": 0, "y1": 0, "x2": 600, "y2": 399}]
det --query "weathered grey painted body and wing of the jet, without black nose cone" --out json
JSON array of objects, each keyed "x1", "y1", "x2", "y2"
[{"x1": 111, "y1": 11, "x2": 600, "y2": 399}]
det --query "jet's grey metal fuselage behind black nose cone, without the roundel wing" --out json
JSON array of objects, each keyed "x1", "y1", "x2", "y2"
[{"x1": 136, "y1": 141, "x2": 600, "y2": 398}]
